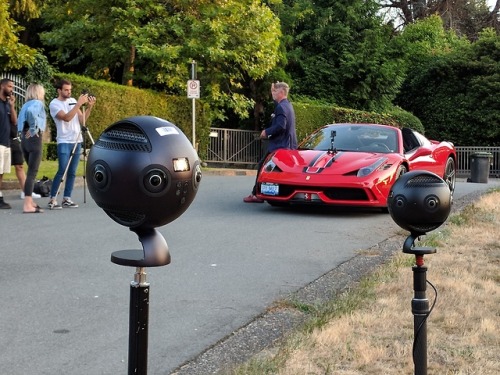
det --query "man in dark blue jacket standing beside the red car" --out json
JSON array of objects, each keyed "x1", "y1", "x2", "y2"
[{"x1": 243, "y1": 82, "x2": 297, "y2": 203}]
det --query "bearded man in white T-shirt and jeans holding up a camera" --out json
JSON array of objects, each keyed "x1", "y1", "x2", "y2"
[{"x1": 48, "y1": 79, "x2": 96, "y2": 210}]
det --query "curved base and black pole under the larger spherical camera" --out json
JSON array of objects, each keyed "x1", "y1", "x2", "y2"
[{"x1": 111, "y1": 228, "x2": 170, "y2": 375}]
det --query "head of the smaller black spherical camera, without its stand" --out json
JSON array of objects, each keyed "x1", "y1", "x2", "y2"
[{"x1": 387, "y1": 171, "x2": 451, "y2": 236}]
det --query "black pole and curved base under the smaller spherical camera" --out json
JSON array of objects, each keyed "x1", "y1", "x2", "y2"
[{"x1": 403, "y1": 233, "x2": 436, "y2": 375}]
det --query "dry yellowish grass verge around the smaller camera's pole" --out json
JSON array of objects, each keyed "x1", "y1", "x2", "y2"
[{"x1": 234, "y1": 192, "x2": 500, "y2": 375}]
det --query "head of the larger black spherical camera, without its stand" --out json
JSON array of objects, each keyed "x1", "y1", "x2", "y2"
[{"x1": 86, "y1": 116, "x2": 202, "y2": 229}]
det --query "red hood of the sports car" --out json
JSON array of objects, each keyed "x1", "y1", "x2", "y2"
[{"x1": 271, "y1": 149, "x2": 401, "y2": 175}]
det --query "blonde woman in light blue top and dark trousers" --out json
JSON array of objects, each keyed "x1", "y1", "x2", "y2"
[{"x1": 17, "y1": 84, "x2": 47, "y2": 213}]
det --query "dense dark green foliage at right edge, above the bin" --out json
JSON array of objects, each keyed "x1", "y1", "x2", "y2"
[{"x1": 397, "y1": 28, "x2": 500, "y2": 146}]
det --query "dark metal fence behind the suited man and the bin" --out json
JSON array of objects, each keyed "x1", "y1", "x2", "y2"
[{"x1": 205, "y1": 128, "x2": 500, "y2": 176}]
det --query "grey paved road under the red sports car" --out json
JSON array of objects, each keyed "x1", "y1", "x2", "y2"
[{"x1": 0, "y1": 175, "x2": 500, "y2": 375}]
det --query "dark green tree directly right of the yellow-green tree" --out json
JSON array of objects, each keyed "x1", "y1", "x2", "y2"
[{"x1": 278, "y1": 0, "x2": 403, "y2": 110}]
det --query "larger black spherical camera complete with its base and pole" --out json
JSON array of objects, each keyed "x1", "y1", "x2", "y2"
[{"x1": 86, "y1": 116, "x2": 202, "y2": 375}]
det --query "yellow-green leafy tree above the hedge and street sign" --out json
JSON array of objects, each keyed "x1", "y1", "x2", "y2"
[{"x1": 42, "y1": 0, "x2": 280, "y2": 118}]
